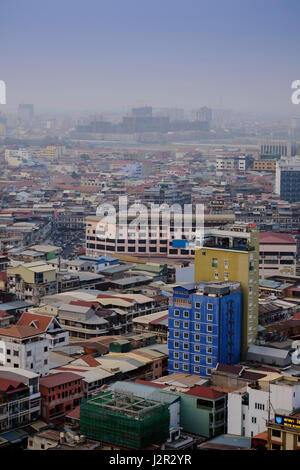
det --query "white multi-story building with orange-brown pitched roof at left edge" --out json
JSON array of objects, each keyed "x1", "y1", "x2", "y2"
[{"x1": 0, "y1": 325, "x2": 50, "y2": 376}]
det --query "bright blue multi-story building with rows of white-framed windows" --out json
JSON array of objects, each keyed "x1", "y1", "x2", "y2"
[{"x1": 168, "y1": 281, "x2": 242, "y2": 377}]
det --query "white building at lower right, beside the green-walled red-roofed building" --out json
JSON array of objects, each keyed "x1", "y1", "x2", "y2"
[{"x1": 227, "y1": 373, "x2": 300, "y2": 437}]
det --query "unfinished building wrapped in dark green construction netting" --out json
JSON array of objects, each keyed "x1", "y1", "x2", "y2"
[{"x1": 80, "y1": 391, "x2": 170, "y2": 449}]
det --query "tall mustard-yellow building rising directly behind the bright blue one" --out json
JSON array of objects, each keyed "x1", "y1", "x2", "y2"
[{"x1": 195, "y1": 223, "x2": 259, "y2": 359}]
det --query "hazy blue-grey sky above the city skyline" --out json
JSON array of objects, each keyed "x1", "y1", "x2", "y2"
[{"x1": 0, "y1": 0, "x2": 300, "y2": 115}]
